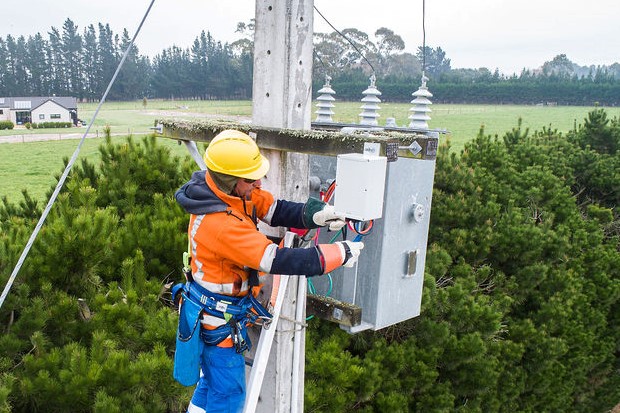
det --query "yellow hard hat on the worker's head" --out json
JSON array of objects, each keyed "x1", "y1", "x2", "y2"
[{"x1": 204, "y1": 129, "x2": 269, "y2": 179}]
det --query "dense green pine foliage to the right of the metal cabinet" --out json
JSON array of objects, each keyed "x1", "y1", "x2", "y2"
[{"x1": 306, "y1": 109, "x2": 620, "y2": 412}]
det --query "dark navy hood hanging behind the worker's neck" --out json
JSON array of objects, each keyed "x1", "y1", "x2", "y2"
[{"x1": 174, "y1": 171, "x2": 228, "y2": 215}]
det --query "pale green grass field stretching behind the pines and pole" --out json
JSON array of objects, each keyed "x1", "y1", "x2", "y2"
[{"x1": 0, "y1": 101, "x2": 620, "y2": 202}]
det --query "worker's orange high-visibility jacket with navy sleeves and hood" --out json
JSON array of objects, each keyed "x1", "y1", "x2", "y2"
[{"x1": 175, "y1": 171, "x2": 341, "y2": 347}]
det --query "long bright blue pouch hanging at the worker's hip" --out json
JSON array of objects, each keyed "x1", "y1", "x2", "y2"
[{"x1": 173, "y1": 292, "x2": 204, "y2": 386}]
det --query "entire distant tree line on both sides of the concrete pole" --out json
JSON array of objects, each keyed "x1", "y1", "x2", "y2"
[{"x1": 0, "y1": 19, "x2": 620, "y2": 105}]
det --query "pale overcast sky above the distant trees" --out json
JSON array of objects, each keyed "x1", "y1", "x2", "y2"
[{"x1": 0, "y1": 0, "x2": 620, "y2": 74}]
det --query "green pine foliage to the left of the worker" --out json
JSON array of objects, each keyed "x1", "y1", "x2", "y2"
[{"x1": 0, "y1": 137, "x2": 190, "y2": 412}]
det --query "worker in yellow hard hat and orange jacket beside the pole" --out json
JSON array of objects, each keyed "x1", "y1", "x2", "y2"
[{"x1": 173, "y1": 130, "x2": 364, "y2": 413}]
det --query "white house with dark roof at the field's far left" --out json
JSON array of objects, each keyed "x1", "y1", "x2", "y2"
[{"x1": 0, "y1": 96, "x2": 78, "y2": 125}]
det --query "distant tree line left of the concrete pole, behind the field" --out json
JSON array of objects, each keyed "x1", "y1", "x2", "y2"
[{"x1": 0, "y1": 19, "x2": 252, "y2": 101}]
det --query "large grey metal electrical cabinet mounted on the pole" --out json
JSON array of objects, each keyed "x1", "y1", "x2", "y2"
[{"x1": 311, "y1": 138, "x2": 436, "y2": 333}]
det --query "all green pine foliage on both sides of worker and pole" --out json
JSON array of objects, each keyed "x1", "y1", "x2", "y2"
[{"x1": 0, "y1": 109, "x2": 620, "y2": 413}]
